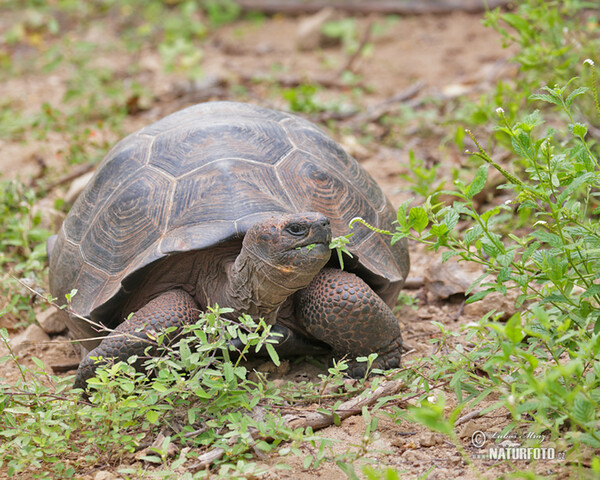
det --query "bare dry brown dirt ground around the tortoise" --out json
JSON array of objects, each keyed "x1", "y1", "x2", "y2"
[{"x1": 0, "y1": 4, "x2": 567, "y2": 479}]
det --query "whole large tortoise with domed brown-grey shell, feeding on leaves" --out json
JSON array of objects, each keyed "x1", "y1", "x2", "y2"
[{"x1": 48, "y1": 102, "x2": 409, "y2": 388}]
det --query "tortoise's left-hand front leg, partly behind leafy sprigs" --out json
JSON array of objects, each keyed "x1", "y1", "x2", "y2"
[{"x1": 74, "y1": 290, "x2": 199, "y2": 389}]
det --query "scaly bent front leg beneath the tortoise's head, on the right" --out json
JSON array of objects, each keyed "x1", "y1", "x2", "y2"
[{"x1": 298, "y1": 268, "x2": 402, "y2": 378}]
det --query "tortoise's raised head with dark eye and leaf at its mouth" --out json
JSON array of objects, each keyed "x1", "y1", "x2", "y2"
[{"x1": 244, "y1": 212, "x2": 331, "y2": 284}]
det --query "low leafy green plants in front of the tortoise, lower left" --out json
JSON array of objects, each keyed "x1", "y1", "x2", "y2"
[{"x1": 0, "y1": 308, "x2": 290, "y2": 476}]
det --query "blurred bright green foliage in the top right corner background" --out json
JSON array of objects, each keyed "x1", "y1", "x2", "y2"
[{"x1": 462, "y1": 0, "x2": 600, "y2": 131}]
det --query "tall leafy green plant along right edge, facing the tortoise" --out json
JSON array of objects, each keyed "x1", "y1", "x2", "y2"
[{"x1": 393, "y1": 70, "x2": 600, "y2": 458}]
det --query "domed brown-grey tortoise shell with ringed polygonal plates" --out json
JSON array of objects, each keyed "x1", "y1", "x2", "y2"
[{"x1": 50, "y1": 102, "x2": 408, "y2": 338}]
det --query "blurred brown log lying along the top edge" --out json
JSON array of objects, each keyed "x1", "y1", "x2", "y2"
[{"x1": 236, "y1": 0, "x2": 509, "y2": 15}]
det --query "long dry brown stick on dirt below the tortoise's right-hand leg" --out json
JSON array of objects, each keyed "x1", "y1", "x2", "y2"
[{"x1": 188, "y1": 380, "x2": 404, "y2": 471}]
